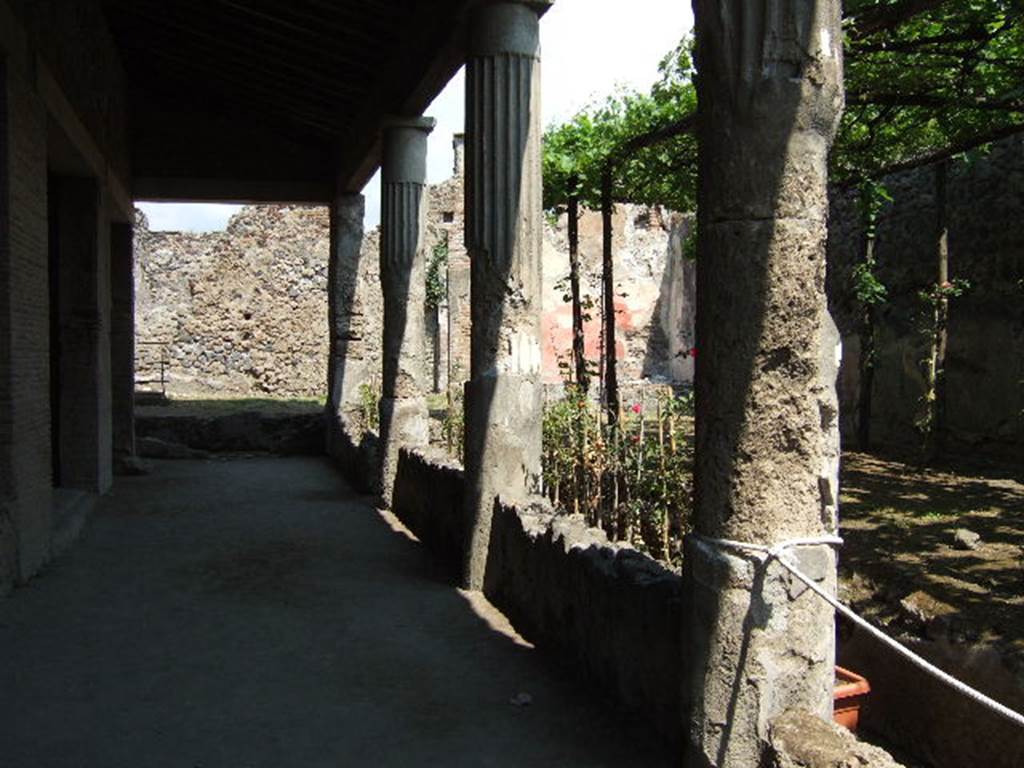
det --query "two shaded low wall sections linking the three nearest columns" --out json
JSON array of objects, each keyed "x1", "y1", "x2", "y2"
[{"x1": 393, "y1": 451, "x2": 682, "y2": 746}]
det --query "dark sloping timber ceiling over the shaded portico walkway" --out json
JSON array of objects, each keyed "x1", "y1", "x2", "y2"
[{"x1": 102, "y1": 0, "x2": 478, "y2": 201}]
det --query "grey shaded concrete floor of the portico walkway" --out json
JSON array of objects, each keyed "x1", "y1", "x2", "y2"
[{"x1": 0, "y1": 459, "x2": 667, "y2": 768}]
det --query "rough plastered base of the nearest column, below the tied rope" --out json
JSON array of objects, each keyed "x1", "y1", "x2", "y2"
[{"x1": 683, "y1": 537, "x2": 836, "y2": 768}]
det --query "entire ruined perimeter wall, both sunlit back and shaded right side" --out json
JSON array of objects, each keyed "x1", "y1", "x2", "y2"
[{"x1": 136, "y1": 131, "x2": 1024, "y2": 451}]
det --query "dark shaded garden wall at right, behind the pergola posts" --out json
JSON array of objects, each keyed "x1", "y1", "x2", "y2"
[{"x1": 828, "y1": 135, "x2": 1024, "y2": 455}]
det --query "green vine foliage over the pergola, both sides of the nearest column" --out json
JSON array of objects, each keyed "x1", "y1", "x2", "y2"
[{"x1": 544, "y1": 0, "x2": 1024, "y2": 210}]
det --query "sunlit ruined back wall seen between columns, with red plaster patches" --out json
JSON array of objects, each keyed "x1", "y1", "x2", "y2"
[{"x1": 135, "y1": 153, "x2": 695, "y2": 397}]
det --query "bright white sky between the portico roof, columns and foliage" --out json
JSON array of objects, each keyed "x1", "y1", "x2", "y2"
[{"x1": 138, "y1": 0, "x2": 693, "y2": 231}]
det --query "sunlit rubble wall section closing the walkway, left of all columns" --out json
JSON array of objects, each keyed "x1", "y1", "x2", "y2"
[{"x1": 135, "y1": 206, "x2": 330, "y2": 397}]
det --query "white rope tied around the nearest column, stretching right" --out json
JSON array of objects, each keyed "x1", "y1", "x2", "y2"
[{"x1": 691, "y1": 534, "x2": 1024, "y2": 727}]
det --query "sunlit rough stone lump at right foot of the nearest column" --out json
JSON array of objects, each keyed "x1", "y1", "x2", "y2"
[{"x1": 764, "y1": 710, "x2": 902, "y2": 768}]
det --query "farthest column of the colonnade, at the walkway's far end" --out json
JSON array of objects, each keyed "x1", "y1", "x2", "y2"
[{"x1": 327, "y1": 194, "x2": 371, "y2": 434}]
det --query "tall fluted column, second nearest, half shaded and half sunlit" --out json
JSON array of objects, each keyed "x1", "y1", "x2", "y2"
[{"x1": 464, "y1": 2, "x2": 542, "y2": 589}]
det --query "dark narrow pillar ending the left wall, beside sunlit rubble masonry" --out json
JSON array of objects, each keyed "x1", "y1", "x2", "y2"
[{"x1": 111, "y1": 222, "x2": 135, "y2": 458}]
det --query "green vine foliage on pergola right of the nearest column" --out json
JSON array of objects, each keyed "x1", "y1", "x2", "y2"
[{"x1": 831, "y1": 0, "x2": 1024, "y2": 179}]
